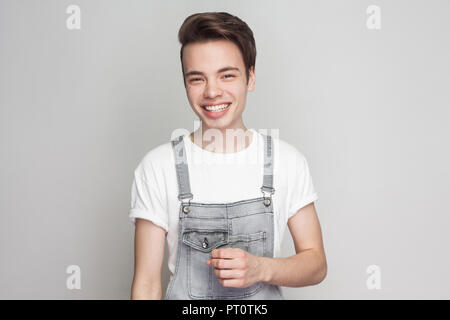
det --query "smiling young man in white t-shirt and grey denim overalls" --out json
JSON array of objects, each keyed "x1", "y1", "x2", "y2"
[{"x1": 129, "y1": 12, "x2": 327, "y2": 299}]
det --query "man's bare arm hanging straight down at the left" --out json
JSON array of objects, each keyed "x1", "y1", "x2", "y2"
[{"x1": 131, "y1": 218, "x2": 166, "y2": 300}]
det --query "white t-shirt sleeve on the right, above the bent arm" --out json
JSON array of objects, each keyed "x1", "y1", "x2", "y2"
[{"x1": 288, "y1": 150, "x2": 318, "y2": 219}]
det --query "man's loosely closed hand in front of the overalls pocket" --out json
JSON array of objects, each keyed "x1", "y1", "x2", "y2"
[{"x1": 206, "y1": 248, "x2": 263, "y2": 288}]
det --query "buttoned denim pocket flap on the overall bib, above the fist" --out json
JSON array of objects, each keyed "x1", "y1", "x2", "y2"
[{"x1": 183, "y1": 230, "x2": 228, "y2": 252}]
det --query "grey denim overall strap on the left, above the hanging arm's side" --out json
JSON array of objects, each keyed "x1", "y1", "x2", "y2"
[{"x1": 172, "y1": 135, "x2": 194, "y2": 202}]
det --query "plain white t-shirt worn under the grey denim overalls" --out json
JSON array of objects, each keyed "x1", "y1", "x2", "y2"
[{"x1": 129, "y1": 129, "x2": 318, "y2": 274}]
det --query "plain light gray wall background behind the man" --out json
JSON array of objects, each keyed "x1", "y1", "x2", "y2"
[{"x1": 0, "y1": 0, "x2": 450, "y2": 299}]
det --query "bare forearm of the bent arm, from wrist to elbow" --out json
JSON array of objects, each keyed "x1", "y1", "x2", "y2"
[{"x1": 260, "y1": 249, "x2": 327, "y2": 287}]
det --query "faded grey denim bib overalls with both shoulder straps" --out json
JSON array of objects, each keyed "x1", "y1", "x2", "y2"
[{"x1": 165, "y1": 134, "x2": 283, "y2": 300}]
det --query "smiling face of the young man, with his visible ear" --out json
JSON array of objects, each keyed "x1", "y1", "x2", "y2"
[{"x1": 183, "y1": 40, "x2": 255, "y2": 130}]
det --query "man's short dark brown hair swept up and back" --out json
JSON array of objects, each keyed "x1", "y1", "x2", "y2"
[{"x1": 178, "y1": 12, "x2": 256, "y2": 86}]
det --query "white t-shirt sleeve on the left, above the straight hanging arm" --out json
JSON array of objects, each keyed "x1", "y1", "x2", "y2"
[{"x1": 129, "y1": 163, "x2": 169, "y2": 232}]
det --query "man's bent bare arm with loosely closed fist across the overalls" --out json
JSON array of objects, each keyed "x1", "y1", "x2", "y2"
[{"x1": 206, "y1": 203, "x2": 327, "y2": 288}]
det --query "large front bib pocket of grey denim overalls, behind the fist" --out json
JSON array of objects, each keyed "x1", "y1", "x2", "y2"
[{"x1": 183, "y1": 230, "x2": 266, "y2": 299}]
